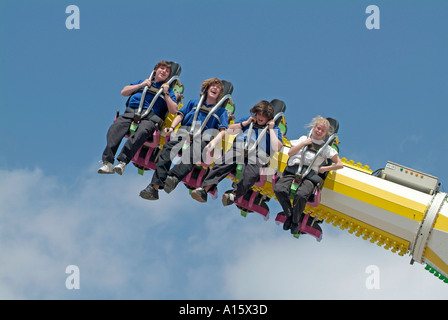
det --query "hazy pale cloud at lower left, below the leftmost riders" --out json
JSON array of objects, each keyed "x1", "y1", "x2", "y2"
[{"x1": 0, "y1": 169, "x2": 184, "y2": 299}]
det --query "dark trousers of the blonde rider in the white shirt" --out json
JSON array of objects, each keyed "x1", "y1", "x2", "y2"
[{"x1": 274, "y1": 173, "x2": 314, "y2": 223}]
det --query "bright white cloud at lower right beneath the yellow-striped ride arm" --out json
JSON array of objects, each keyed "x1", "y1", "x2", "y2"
[{"x1": 220, "y1": 225, "x2": 448, "y2": 300}]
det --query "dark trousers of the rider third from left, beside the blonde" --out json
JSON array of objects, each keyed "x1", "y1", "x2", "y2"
[{"x1": 202, "y1": 146, "x2": 263, "y2": 199}]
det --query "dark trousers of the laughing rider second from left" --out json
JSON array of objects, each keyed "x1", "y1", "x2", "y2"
[{"x1": 150, "y1": 132, "x2": 209, "y2": 189}]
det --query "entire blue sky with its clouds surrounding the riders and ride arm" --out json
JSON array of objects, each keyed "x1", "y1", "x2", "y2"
[{"x1": 0, "y1": 0, "x2": 448, "y2": 299}]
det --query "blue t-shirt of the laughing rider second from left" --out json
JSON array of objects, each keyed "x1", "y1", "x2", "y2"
[{"x1": 177, "y1": 99, "x2": 229, "y2": 130}]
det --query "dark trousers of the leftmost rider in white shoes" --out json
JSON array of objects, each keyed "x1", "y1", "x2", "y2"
[{"x1": 103, "y1": 113, "x2": 156, "y2": 163}]
